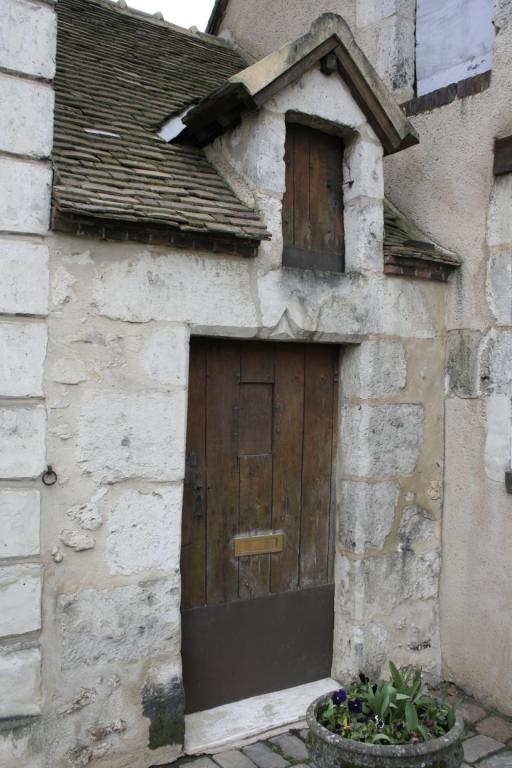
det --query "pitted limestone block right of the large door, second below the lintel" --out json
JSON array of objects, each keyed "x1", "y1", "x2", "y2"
[{"x1": 341, "y1": 404, "x2": 424, "y2": 477}]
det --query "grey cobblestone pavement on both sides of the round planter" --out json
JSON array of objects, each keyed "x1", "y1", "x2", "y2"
[{"x1": 173, "y1": 689, "x2": 512, "y2": 768}]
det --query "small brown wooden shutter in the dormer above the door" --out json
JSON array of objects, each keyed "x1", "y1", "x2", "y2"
[{"x1": 283, "y1": 123, "x2": 344, "y2": 272}]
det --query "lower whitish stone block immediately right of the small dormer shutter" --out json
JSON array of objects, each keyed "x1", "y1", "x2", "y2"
[{"x1": 343, "y1": 197, "x2": 384, "y2": 273}]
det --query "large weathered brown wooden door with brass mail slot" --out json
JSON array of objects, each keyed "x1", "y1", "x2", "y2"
[{"x1": 181, "y1": 339, "x2": 338, "y2": 712}]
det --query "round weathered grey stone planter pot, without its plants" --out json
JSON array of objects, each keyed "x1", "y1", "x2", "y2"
[{"x1": 306, "y1": 694, "x2": 464, "y2": 768}]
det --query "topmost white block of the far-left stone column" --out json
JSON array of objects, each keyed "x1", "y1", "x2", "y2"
[{"x1": 0, "y1": 0, "x2": 57, "y2": 79}]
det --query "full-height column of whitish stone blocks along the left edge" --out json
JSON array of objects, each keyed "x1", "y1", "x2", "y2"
[{"x1": 0, "y1": 0, "x2": 56, "y2": 768}]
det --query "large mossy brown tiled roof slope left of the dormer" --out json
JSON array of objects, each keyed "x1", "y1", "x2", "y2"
[{"x1": 53, "y1": 0, "x2": 266, "y2": 240}]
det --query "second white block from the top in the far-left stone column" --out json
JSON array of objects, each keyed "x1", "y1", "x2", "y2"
[{"x1": 0, "y1": 75, "x2": 54, "y2": 157}]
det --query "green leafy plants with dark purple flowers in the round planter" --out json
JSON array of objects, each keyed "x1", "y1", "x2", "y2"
[{"x1": 318, "y1": 661, "x2": 459, "y2": 745}]
